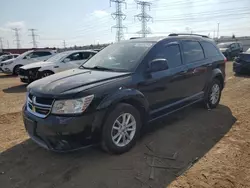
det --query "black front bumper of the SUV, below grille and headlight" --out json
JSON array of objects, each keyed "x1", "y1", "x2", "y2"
[{"x1": 23, "y1": 106, "x2": 104, "y2": 152}]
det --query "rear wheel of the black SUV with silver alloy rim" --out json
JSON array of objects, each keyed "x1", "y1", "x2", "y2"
[{"x1": 204, "y1": 78, "x2": 222, "y2": 109}]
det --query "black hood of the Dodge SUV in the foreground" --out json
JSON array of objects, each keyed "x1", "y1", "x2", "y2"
[{"x1": 28, "y1": 68, "x2": 130, "y2": 97}]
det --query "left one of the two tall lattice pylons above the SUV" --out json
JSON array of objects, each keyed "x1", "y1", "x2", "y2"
[{"x1": 110, "y1": 0, "x2": 127, "y2": 42}]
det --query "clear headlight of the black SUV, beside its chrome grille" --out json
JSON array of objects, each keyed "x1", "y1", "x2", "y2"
[{"x1": 52, "y1": 95, "x2": 94, "y2": 114}]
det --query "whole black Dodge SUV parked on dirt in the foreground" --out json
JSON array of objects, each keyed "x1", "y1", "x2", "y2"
[{"x1": 23, "y1": 34, "x2": 225, "y2": 153}]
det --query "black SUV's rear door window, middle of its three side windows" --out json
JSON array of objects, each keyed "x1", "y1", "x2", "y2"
[{"x1": 183, "y1": 41, "x2": 205, "y2": 64}]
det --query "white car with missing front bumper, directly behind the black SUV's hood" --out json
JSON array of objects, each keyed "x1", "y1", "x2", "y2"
[{"x1": 19, "y1": 50, "x2": 97, "y2": 83}]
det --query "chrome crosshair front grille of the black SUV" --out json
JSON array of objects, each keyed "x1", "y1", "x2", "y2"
[{"x1": 27, "y1": 93, "x2": 54, "y2": 118}]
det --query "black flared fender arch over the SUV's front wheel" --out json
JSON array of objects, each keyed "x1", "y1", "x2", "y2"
[{"x1": 97, "y1": 88, "x2": 149, "y2": 112}]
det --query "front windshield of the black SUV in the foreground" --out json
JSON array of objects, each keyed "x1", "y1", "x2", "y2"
[{"x1": 81, "y1": 42, "x2": 153, "y2": 71}]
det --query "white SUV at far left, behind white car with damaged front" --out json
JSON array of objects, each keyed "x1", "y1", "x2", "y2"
[{"x1": 0, "y1": 50, "x2": 56, "y2": 75}]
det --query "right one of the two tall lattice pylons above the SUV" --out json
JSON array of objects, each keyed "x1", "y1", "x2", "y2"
[{"x1": 135, "y1": 1, "x2": 153, "y2": 37}]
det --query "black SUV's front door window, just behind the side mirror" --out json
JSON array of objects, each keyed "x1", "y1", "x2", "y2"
[{"x1": 152, "y1": 44, "x2": 182, "y2": 68}]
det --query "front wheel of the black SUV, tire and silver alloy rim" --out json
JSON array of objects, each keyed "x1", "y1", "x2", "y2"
[{"x1": 102, "y1": 103, "x2": 142, "y2": 154}]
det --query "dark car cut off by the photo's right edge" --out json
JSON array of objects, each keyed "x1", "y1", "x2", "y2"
[{"x1": 233, "y1": 48, "x2": 250, "y2": 74}]
